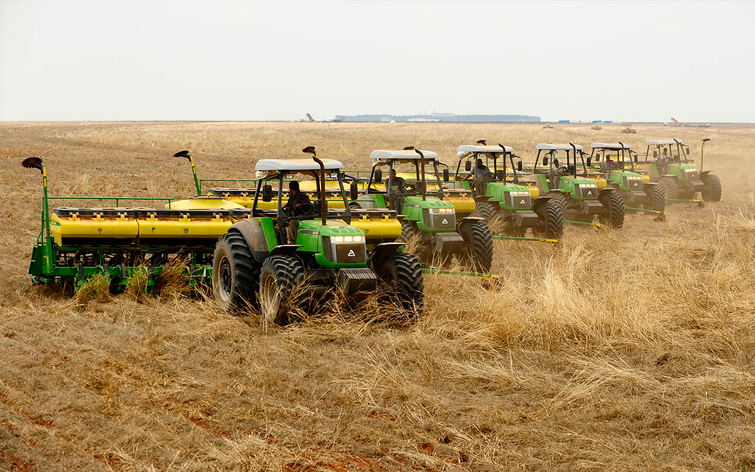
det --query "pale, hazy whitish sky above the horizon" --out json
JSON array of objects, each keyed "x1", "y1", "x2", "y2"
[{"x1": 0, "y1": 0, "x2": 755, "y2": 122}]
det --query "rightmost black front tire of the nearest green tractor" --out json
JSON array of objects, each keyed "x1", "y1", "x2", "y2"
[{"x1": 378, "y1": 252, "x2": 425, "y2": 318}]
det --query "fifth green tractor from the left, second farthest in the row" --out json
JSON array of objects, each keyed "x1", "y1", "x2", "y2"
[{"x1": 587, "y1": 142, "x2": 666, "y2": 218}]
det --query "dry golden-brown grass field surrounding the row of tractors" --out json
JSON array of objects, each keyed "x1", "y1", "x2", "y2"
[{"x1": 0, "y1": 122, "x2": 755, "y2": 472}]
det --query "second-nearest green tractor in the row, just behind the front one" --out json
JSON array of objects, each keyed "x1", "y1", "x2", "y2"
[{"x1": 367, "y1": 147, "x2": 493, "y2": 272}]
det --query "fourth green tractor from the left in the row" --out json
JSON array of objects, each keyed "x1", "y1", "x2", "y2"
[{"x1": 519, "y1": 143, "x2": 624, "y2": 228}]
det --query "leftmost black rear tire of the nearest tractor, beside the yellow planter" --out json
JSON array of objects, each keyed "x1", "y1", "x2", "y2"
[{"x1": 212, "y1": 231, "x2": 262, "y2": 313}]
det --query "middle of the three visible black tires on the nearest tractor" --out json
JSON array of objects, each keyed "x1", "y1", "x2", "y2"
[{"x1": 259, "y1": 255, "x2": 305, "y2": 325}]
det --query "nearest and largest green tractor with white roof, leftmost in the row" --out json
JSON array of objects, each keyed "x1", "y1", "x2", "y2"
[{"x1": 212, "y1": 146, "x2": 424, "y2": 323}]
